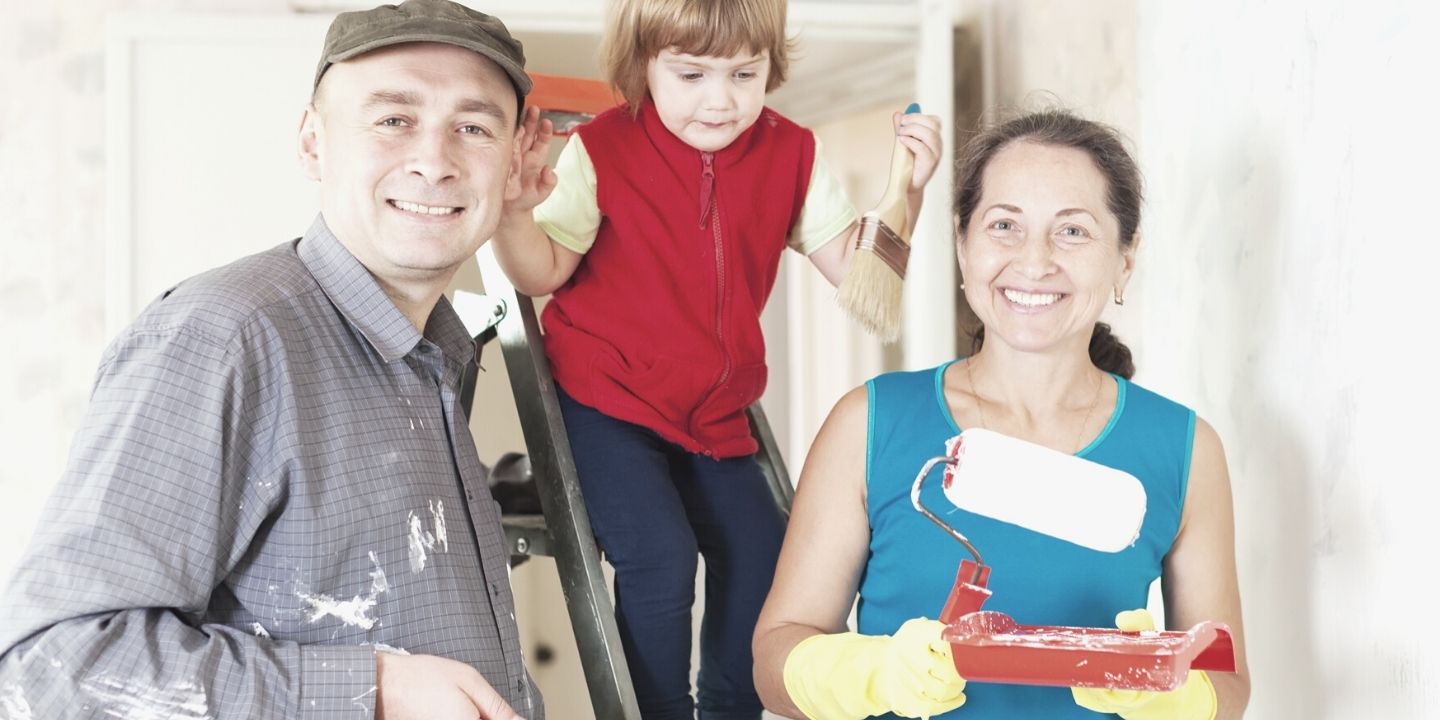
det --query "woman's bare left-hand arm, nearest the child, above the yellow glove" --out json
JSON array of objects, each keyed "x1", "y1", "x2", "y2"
[{"x1": 753, "y1": 387, "x2": 870, "y2": 717}]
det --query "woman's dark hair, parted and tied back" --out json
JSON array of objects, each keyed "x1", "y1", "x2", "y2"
[{"x1": 955, "y1": 109, "x2": 1143, "y2": 377}]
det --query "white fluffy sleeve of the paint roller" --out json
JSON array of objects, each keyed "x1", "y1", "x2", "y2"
[{"x1": 945, "y1": 428, "x2": 1145, "y2": 553}]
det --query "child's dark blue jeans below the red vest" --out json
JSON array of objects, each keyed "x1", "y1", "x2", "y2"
[{"x1": 559, "y1": 390, "x2": 785, "y2": 720}]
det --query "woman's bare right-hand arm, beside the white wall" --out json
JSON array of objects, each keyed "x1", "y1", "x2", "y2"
[{"x1": 1161, "y1": 418, "x2": 1250, "y2": 720}]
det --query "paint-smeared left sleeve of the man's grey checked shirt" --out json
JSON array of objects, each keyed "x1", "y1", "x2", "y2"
[{"x1": 0, "y1": 327, "x2": 374, "y2": 719}]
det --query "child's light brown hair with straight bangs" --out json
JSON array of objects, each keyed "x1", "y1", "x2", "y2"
[{"x1": 600, "y1": 0, "x2": 791, "y2": 114}]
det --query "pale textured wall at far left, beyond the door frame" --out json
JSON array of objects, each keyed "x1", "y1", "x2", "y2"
[{"x1": 0, "y1": 0, "x2": 285, "y2": 582}]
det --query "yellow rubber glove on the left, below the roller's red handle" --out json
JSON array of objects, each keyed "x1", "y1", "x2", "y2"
[{"x1": 785, "y1": 618, "x2": 965, "y2": 720}]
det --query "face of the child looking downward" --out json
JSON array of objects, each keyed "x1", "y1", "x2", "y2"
[{"x1": 647, "y1": 48, "x2": 770, "y2": 153}]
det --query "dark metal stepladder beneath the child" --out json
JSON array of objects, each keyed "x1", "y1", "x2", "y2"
[{"x1": 462, "y1": 245, "x2": 795, "y2": 720}]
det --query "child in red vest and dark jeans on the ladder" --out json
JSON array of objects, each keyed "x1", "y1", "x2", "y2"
[{"x1": 494, "y1": 0, "x2": 940, "y2": 719}]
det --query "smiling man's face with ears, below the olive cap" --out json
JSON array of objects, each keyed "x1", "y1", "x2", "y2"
[{"x1": 301, "y1": 43, "x2": 520, "y2": 291}]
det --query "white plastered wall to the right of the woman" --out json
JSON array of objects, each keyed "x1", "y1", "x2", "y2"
[{"x1": 1126, "y1": 0, "x2": 1440, "y2": 719}]
